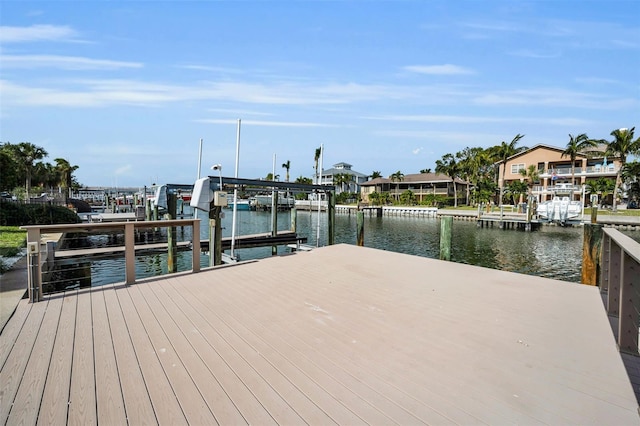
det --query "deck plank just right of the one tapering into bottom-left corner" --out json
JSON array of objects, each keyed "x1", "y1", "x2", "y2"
[{"x1": 7, "y1": 297, "x2": 62, "y2": 424}]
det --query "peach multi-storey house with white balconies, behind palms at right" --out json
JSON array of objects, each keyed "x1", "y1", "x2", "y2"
[{"x1": 498, "y1": 145, "x2": 620, "y2": 206}]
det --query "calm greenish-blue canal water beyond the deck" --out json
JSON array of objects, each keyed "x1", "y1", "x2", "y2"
[{"x1": 74, "y1": 206, "x2": 640, "y2": 286}]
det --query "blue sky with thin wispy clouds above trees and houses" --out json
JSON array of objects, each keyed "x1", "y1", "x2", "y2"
[{"x1": 0, "y1": 0, "x2": 640, "y2": 186}]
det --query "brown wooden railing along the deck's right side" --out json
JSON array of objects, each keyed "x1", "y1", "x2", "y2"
[{"x1": 600, "y1": 228, "x2": 640, "y2": 356}]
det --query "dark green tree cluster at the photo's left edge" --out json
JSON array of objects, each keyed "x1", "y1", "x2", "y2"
[{"x1": 0, "y1": 142, "x2": 81, "y2": 200}]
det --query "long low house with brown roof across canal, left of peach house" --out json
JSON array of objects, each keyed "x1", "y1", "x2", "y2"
[{"x1": 360, "y1": 173, "x2": 469, "y2": 203}]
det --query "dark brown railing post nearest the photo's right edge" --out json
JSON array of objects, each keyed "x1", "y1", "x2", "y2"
[{"x1": 618, "y1": 252, "x2": 640, "y2": 355}]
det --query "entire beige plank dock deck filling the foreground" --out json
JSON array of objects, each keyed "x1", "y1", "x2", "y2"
[{"x1": 0, "y1": 245, "x2": 640, "y2": 425}]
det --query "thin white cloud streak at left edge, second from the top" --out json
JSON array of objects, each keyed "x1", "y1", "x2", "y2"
[{"x1": 0, "y1": 55, "x2": 143, "y2": 70}]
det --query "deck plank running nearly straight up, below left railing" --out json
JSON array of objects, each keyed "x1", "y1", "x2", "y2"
[{"x1": 67, "y1": 291, "x2": 98, "y2": 426}]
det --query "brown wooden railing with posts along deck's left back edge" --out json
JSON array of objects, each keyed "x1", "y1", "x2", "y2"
[{"x1": 22, "y1": 219, "x2": 200, "y2": 302}]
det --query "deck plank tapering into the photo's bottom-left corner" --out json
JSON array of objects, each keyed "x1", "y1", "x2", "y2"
[{"x1": 0, "y1": 302, "x2": 47, "y2": 424}]
